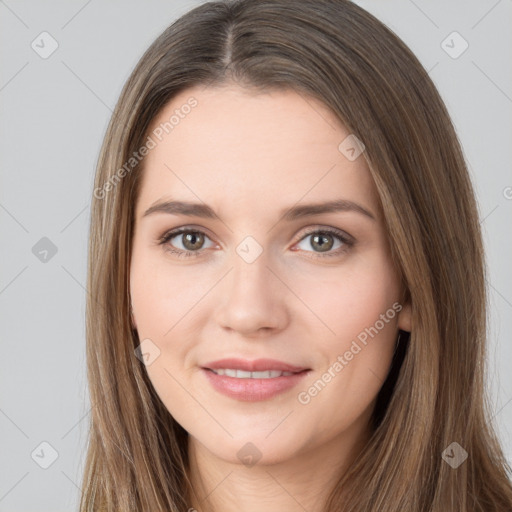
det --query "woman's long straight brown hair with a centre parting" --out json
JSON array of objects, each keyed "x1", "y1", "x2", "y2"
[{"x1": 80, "y1": 0, "x2": 512, "y2": 512}]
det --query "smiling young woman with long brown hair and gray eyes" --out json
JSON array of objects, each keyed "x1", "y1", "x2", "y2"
[{"x1": 81, "y1": 0, "x2": 512, "y2": 512}]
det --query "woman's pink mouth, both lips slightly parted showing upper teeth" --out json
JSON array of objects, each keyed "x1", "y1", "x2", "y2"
[{"x1": 201, "y1": 359, "x2": 311, "y2": 402}]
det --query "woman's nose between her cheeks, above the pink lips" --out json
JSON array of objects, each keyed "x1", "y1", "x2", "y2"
[{"x1": 216, "y1": 246, "x2": 290, "y2": 337}]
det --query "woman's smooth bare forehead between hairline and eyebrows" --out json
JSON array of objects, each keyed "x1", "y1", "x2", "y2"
[{"x1": 134, "y1": 86, "x2": 376, "y2": 222}]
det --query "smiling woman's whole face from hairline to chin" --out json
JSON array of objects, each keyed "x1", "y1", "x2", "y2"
[{"x1": 130, "y1": 86, "x2": 410, "y2": 463}]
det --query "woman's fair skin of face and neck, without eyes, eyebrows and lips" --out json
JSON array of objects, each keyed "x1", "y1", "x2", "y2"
[{"x1": 130, "y1": 84, "x2": 410, "y2": 512}]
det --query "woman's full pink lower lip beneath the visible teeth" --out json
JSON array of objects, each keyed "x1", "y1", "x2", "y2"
[{"x1": 201, "y1": 368, "x2": 309, "y2": 402}]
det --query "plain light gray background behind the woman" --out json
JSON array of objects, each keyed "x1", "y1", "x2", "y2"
[{"x1": 0, "y1": 0, "x2": 512, "y2": 512}]
